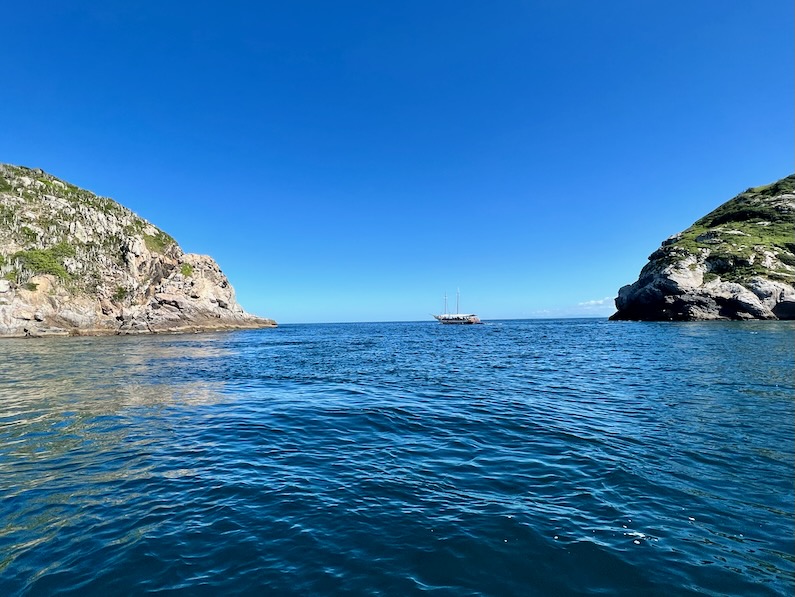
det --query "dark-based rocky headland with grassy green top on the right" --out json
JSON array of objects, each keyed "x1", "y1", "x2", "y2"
[{"x1": 611, "y1": 175, "x2": 795, "y2": 321}]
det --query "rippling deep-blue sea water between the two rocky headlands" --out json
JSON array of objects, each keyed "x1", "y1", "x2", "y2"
[{"x1": 0, "y1": 320, "x2": 795, "y2": 596}]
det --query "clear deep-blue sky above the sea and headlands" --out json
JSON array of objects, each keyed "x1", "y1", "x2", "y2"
[{"x1": 0, "y1": 0, "x2": 794, "y2": 323}]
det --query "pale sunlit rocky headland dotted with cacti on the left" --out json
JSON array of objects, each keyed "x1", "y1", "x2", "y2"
[{"x1": 0, "y1": 164, "x2": 275, "y2": 336}]
